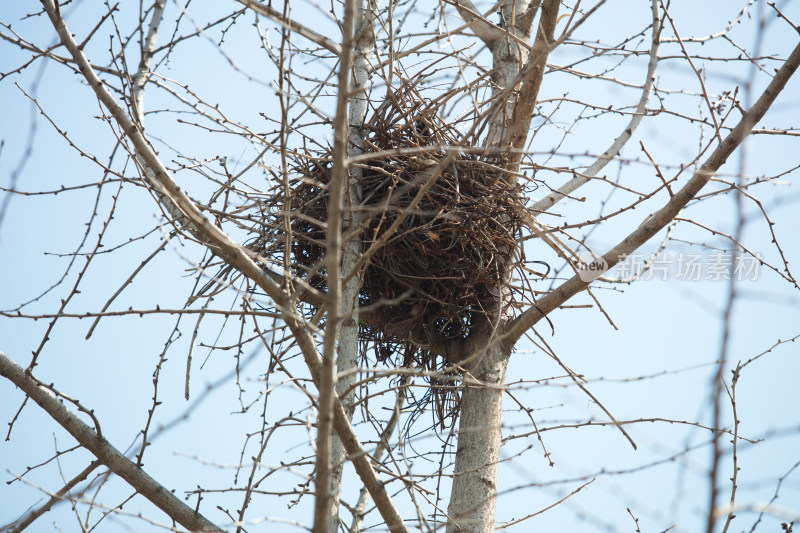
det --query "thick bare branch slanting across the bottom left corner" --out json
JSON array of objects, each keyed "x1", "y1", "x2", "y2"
[{"x1": 0, "y1": 351, "x2": 223, "y2": 531}]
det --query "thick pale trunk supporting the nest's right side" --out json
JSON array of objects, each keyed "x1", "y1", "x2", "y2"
[{"x1": 447, "y1": 0, "x2": 560, "y2": 533}]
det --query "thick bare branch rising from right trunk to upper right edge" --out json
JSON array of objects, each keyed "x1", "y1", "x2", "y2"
[{"x1": 504, "y1": 37, "x2": 800, "y2": 345}]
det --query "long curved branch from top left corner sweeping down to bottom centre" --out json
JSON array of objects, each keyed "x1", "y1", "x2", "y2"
[{"x1": 41, "y1": 0, "x2": 408, "y2": 532}]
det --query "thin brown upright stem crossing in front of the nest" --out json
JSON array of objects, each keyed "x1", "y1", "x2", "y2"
[{"x1": 313, "y1": 0, "x2": 356, "y2": 533}]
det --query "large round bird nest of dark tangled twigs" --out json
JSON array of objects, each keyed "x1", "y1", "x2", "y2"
[{"x1": 251, "y1": 87, "x2": 524, "y2": 423}]
